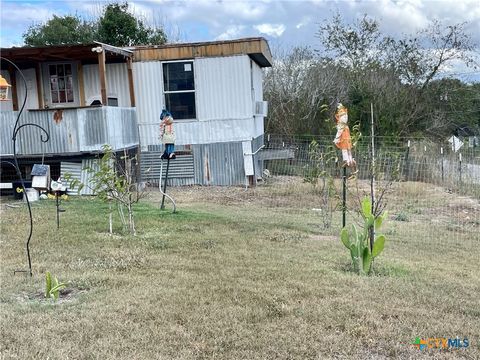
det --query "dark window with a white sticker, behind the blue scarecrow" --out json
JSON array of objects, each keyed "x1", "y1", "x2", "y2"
[{"x1": 163, "y1": 61, "x2": 197, "y2": 120}]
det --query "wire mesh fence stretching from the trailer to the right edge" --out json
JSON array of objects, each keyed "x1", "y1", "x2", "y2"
[{"x1": 259, "y1": 135, "x2": 480, "y2": 252}]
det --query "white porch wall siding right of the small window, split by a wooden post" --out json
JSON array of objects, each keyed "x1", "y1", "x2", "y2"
[{"x1": 83, "y1": 63, "x2": 130, "y2": 107}]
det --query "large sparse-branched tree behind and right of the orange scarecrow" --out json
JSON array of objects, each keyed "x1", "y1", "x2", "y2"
[{"x1": 317, "y1": 14, "x2": 475, "y2": 136}]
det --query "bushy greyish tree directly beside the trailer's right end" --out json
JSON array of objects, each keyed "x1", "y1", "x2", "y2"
[{"x1": 264, "y1": 47, "x2": 343, "y2": 135}]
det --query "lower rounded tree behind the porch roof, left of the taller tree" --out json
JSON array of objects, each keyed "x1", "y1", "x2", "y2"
[{"x1": 23, "y1": 15, "x2": 96, "y2": 46}]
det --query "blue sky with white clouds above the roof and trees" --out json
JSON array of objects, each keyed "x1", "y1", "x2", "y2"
[{"x1": 0, "y1": 0, "x2": 480, "y2": 79}]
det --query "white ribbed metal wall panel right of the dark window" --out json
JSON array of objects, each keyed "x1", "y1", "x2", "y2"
[{"x1": 195, "y1": 55, "x2": 253, "y2": 121}]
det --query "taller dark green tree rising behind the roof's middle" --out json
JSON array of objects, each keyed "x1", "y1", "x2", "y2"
[{"x1": 97, "y1": 3, "x2": 167, "y2": 46}]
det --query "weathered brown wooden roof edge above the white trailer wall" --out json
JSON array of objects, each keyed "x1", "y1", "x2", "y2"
[{"x1": 131, "y1": 38, "x2": 272, "y2": 67}]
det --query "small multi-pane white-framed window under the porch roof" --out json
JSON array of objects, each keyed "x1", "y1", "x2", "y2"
[{"x1": 48, "y1": 63, "x2": 75, "y2": 105}]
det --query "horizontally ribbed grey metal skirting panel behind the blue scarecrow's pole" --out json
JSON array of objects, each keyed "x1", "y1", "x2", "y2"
[{"x1": 140, "y1": 151, "x2": 195, "y2": 186}]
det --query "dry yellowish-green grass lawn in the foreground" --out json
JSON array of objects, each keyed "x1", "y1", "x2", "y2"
[{"x1": 0, "y1": 183, "x2": 480, "y2": 359}]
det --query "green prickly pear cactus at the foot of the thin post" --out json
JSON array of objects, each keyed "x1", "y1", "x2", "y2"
[{"x1": 340, "y1": 198, "x2": 387, "y2": 274}]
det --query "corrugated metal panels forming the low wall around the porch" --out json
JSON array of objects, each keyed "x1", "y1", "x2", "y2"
[{"x1": 0, "y1": 107, "x2": 138, "y2": 155}]
